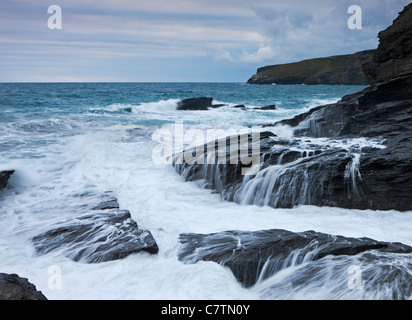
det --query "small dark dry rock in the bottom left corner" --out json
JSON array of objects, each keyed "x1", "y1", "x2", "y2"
[{"x1": 0, "y1": 273, "x2": 47, "y2": 300}]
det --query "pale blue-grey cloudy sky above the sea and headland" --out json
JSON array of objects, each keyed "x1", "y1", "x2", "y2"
[{"x1": 0, "y1": 0, "x2": 411, "y2": 82}]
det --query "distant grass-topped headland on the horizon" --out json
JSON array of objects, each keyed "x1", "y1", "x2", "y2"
[{"x1": 247, "y1": 50, "x2": 374, "y2": 85}]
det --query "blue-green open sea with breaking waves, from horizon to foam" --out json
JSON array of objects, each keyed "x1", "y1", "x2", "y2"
[{"x1": 0, "y1": 83, "x2": 362, "y2": 158}]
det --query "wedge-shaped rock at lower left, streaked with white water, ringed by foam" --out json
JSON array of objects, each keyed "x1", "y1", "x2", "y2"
[{"x1": 32, "y1": 194, "x2": 159, "y2": 263}]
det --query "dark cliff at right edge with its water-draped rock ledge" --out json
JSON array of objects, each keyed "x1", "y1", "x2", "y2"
[{"x1": 175, "y1": 4, "x2": 412, "y2": 211}]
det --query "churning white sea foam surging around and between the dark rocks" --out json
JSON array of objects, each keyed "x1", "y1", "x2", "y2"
[{"x1": 0, "y1": 90, "x2": 412, "y2": 300}]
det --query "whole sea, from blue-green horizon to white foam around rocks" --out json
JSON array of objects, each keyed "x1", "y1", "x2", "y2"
[{"x1": 0, "y1": 83, "x2": 412, "y2": 300}]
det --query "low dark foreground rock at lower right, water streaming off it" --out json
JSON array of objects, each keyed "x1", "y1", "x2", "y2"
[{"x1": 178, "y1": 229, "x2": 412, "y2": 287}]
